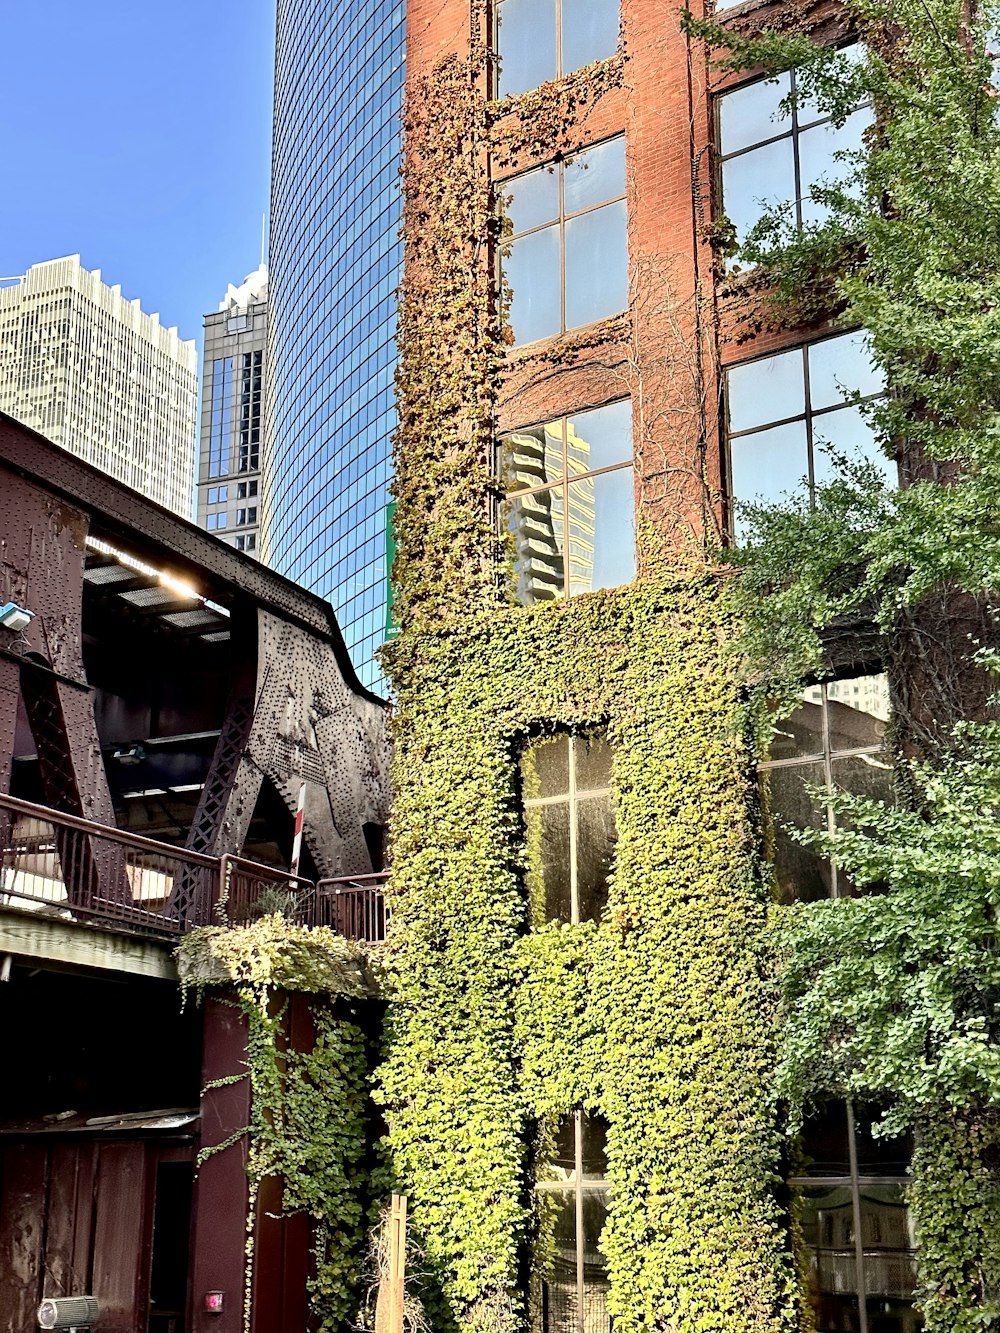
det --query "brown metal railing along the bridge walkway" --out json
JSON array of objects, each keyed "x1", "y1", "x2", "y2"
[{"x1": 0, "y1": 793, "x2": 387, "y2": 942}]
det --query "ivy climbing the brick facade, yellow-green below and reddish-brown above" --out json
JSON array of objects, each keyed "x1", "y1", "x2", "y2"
[{"x1": 376, "y1": 2, "x2": 808, "y2": 1333}]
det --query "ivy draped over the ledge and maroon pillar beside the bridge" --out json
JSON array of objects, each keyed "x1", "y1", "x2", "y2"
[{"x1": 177, "y1": 913, "x2": 371, "y2": 1333}]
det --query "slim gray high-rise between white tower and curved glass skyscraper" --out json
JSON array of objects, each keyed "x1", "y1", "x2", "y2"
[{"x1": 197, "y1": 264, "x2": 268, "y2": 556}]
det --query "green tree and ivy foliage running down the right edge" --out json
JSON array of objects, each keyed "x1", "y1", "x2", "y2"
[{"x1": 689, "y1": 0, "x2": 1000, "y2": 1333}]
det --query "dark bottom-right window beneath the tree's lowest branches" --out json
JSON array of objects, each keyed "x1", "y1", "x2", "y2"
[{"x1": 791, "y1": 1101, "x2": 920, "y2": 1333}]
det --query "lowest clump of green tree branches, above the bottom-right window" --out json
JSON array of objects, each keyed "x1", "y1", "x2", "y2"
[{"x1": 781, "y1": 724, "x2": 1000, "y2": 1132}]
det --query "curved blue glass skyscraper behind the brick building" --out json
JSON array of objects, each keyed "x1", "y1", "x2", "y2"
[{"x1": 261, "y1": 0, "x2": 405, "y2": 688}]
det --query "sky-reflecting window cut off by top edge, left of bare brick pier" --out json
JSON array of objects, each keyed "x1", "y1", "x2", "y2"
[{"x1": 495, "y1": 0, "x2": 619, "y2": 97}]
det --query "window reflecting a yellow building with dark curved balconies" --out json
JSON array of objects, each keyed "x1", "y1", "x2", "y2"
[{"x1": 497, "y1": 399, "x2": 635, "y2": 604}]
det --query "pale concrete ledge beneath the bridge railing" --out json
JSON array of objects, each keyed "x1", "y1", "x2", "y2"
[{"x1": 0, "y1": 908, "x2": 177, "y2": 981}]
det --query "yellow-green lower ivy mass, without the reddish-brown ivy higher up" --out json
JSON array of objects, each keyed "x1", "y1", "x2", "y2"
[{"x1": 380, "y1": 581, "x2": 799, "y2": 1330}]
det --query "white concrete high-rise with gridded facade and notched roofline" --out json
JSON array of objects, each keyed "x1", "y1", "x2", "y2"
[{"x1": 0, "y1": 255, "x2": 197, "y2": 519}]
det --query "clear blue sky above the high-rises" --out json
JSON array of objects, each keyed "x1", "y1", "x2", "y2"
[{"x1": 0, "y1": 0, "x2": 275, "y2": 341}]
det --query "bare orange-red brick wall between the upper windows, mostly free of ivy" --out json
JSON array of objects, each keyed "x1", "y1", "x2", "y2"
[{"x1": 407, "y1": 0, "x2": 840, "y2": 541}]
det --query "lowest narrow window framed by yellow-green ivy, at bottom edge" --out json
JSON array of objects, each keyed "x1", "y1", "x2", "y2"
[{"x1": 535, "y1": 1110, "x2": 611, "y2": 1333}]
